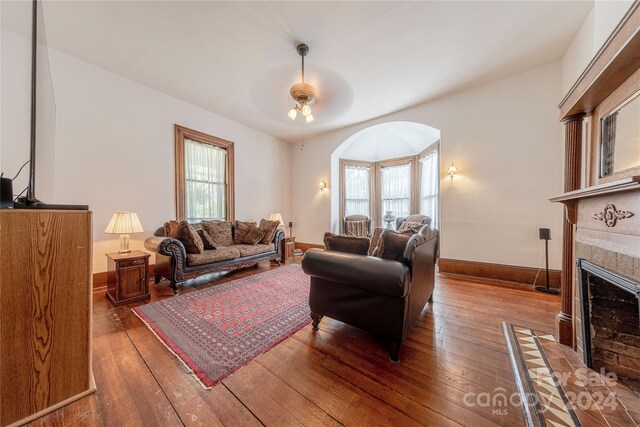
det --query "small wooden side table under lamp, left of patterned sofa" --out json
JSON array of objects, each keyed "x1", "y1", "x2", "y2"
[{"x1": 105, "y1": 251, "x2": 151, "y2": 305}]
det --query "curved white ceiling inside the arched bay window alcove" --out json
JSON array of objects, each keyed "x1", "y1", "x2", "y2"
[{"x1": 339, "y1": 122, "x2": 440, "y2": 162}]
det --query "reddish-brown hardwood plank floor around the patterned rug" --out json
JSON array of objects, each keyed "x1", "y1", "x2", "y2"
[{"x1": 32, "y1": 264, "x2": 560, "y2": 426}]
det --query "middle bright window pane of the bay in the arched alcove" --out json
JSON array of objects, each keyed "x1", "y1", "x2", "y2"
[{"x1": 380, "y1": 162, "x2": 412, "y2": 218}]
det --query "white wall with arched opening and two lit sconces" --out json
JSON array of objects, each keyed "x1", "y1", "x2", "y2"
[{"x1": 291, "y1": 61, "x2": 563, "y2": 269}]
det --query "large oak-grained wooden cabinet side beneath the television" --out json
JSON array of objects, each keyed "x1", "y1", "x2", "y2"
[{"x1": 0, "y1": 209, "x2": 95, "y2": 426}]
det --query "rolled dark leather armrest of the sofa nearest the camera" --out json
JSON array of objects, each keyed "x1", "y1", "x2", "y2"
[{"x1": 302, "y1": 249, "x2": 411, "y2": 298}]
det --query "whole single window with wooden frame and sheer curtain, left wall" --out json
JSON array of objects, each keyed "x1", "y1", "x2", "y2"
[{"x1": 176, "y1": 125, "x2": 234, "y2": 222}]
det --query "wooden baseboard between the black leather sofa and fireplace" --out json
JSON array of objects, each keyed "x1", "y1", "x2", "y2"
[{"x1": 438, "y1": 258, "x2": 560, "y2": 288}]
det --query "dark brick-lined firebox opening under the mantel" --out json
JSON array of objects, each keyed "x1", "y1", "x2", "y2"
[{"x1": 577, "y1": 259, "x2": 640, "y2": 380}]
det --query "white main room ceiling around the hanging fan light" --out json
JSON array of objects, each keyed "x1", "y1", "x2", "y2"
[{"x1": 3, "y1": 1, "x2": 593, "y2": 141}]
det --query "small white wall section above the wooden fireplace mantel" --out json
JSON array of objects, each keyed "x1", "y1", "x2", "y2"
[{"x1": 562, "y1": 0, "x2": 633, "y2": 94}]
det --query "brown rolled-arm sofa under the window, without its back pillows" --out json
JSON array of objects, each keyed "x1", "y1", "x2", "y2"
[{"x1": 144, "y1": 227, "x2": 284, "y2": 293}]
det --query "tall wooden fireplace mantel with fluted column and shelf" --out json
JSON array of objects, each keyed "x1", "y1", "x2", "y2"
[{"x1": 550, "y1": 0, "x2": 640, "y2": 347}]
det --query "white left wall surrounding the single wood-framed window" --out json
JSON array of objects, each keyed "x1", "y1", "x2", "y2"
[{"x1": 1, "y1": 31, "x2": 291, "y2": 273}]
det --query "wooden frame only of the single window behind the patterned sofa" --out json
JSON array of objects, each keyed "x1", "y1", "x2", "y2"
[{"x1": 175, "y1": 125, "x2": 235, "y2": 221}]
